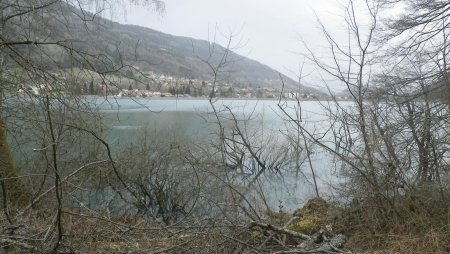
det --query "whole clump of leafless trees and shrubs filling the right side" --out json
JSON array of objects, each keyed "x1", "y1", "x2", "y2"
[{"x1": 280, "y1": 1, "x2": 448, "y2": 250}]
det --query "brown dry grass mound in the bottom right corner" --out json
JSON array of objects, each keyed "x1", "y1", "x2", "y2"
[{"x1": 340, "y1": 188, "x2": 450, "y2": 254}]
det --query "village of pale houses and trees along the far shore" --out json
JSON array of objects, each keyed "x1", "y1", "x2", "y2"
[{"x1": 19, "y1": 72, "x2": 349, "y2": 100}]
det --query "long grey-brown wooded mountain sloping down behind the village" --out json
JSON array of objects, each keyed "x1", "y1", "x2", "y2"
[{"x1": 4, "y1": 1, "x2": 320, "y2": 94}]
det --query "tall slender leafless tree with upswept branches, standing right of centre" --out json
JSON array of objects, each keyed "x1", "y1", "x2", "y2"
[{"x1": 300, "y1": 1, "x2": 383, "y2": 201}]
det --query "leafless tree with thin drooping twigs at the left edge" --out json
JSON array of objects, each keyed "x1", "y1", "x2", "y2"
[{"x1": 0, "y1": 0, "x2": 164, "y2": 252}]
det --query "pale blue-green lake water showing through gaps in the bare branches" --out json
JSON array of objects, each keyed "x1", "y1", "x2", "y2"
[{"x1": 8, "y1": 97, "x2": 342, "y2": 211}]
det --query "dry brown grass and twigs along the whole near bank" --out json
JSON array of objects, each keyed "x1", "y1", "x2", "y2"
[{"x1": 0, "y1": 186, "x2": 450, "y2": 254}]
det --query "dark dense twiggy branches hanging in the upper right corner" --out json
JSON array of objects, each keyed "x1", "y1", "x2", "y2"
[{"x1": 380, "y1": 0, "x2": 450, "y2": 103}]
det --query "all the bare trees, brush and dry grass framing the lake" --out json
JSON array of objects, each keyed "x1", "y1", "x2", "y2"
[{"x1": 0, "y1": 0, "x2": 450, "y2": 253}]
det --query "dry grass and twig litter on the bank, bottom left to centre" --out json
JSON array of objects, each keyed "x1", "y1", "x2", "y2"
[{"x1": 0, "y1": 204, "x2": 251, "y2": 253}]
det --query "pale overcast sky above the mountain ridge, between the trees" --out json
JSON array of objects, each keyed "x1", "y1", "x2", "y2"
[{"x1": 110, "y1": 0, "x2": 354, "y2": 90}]
